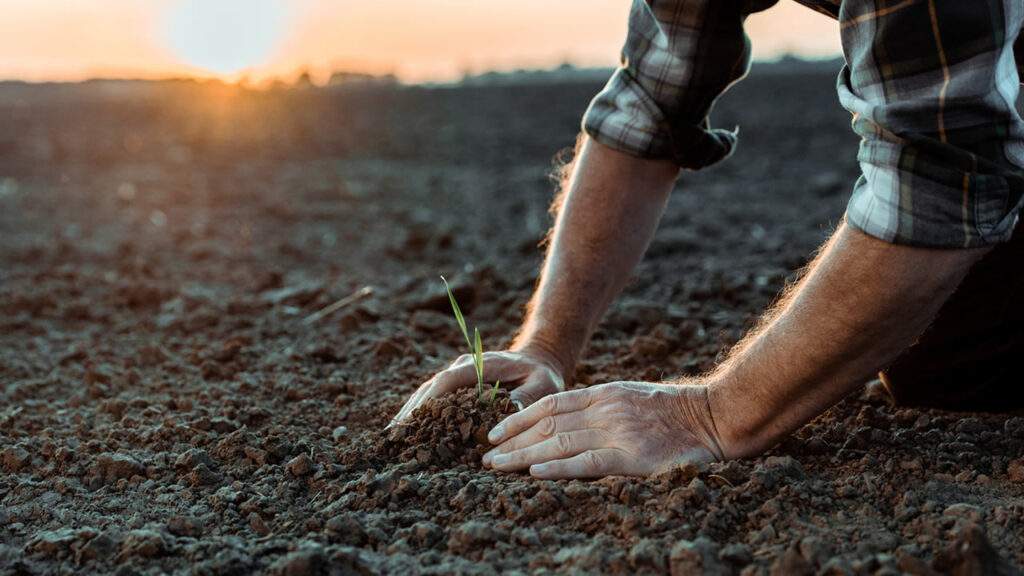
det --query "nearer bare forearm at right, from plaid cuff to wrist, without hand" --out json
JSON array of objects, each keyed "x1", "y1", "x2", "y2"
[{"x1": 709, "y1": 220, "x2": 987, "y2": 458}]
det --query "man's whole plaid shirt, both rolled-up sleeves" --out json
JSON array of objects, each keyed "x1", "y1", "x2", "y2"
[{"x1": 584, "y1": 0, "x2": 1024, "y2": 248}]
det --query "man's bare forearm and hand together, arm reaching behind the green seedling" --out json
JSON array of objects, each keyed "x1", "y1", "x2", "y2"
[{"x1": 387, "y1": 139, "x2": 679, "y2": 428}]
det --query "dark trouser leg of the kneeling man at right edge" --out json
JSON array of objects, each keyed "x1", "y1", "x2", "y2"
[{"x1": 881, "y1": 217, "x2": 1024, "y2": 412}]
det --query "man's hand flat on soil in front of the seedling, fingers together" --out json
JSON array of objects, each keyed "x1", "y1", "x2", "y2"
[{"x1": 483, "y1": 382, "x2": 723, "y2": 479}]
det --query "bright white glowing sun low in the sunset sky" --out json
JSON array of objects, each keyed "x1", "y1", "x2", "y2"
[{"x1": 164, "y1": 0, "x2": 289, "y2": 75}]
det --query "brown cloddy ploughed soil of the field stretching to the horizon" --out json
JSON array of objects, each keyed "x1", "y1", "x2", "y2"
[{"x1": 0, "y1": 66, "x2": 1024, "y2": 575}]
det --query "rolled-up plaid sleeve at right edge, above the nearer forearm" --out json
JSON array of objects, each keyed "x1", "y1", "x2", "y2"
[{"x1": 838, "y1": 0, "x2": 1024, "y2": 243}]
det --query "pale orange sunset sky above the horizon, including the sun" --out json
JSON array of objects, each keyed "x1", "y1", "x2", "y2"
[{"x1": 0, "y1": 0, "x2": 840, "y2": 82}]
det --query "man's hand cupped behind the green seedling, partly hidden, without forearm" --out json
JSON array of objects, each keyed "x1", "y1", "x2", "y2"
[{"x1": 392, "y1": 348, "x2": 565, "y2": 422}]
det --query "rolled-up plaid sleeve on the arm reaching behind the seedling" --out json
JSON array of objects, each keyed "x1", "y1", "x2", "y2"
[{"x1": 583, "y1": 0, "x2": 776, "y2": 169}]
